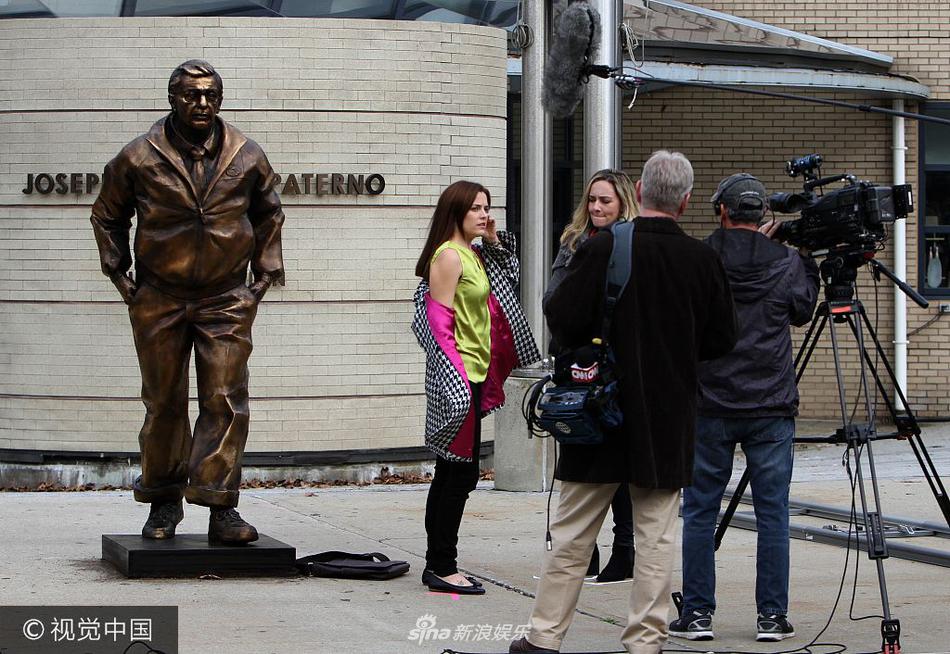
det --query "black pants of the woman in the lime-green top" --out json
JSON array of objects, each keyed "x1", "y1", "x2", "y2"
[{"x1": 426, "y1": 384, "x2": 482, "y2": 577}]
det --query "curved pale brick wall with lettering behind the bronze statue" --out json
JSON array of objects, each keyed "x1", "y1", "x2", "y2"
[{"x1": 0, "y1": 18, "x2": 506, "y2": 452}]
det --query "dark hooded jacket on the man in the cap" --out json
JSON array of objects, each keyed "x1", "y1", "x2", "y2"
[{"x1": 697, "y1": 229, "x2": 819, "y2": 418}]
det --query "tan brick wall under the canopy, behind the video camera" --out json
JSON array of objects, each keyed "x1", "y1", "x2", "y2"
[{"x1": 624, "y1": 89, "x2": 950, "y2": 417}]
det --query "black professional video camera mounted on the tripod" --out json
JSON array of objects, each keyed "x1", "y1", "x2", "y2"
[{"x1": 769, "y1": 154, "x2": 914, "y2": 252}]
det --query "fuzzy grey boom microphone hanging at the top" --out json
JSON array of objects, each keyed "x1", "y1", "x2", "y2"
[{"x1": 541, "y1": 0, "x2": 600, "y2": 118}]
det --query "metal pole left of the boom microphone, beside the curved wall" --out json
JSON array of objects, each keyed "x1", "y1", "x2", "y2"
[{"x1": 521, "y1": 0, "x2": 553, "y2": 351}]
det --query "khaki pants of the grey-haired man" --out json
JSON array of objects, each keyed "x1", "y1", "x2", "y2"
[{"x1": 528, "y1": 482, "x2": 680, "y2": 654}]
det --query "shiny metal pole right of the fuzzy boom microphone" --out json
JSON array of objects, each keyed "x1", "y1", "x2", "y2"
[{"x1": 584, "y1": 0, "x2": 623, "y2": 182}]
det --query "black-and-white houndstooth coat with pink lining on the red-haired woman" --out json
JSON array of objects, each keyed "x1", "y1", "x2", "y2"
[{"x1": 412, "y1": 232, "x2": 541, "y2": 461}]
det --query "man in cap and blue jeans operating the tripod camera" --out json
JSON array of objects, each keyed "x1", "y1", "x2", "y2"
[{"x1": 670, "y1": 173, "x2": 819, "y2": 641}]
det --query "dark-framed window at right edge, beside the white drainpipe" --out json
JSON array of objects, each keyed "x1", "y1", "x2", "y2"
[{"x1": 918, "y1": 103, "x2": 950, "y2": 297}]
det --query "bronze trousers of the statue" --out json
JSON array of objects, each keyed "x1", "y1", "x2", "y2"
[{"x1": 129, "y1": 284, "x2": 257, "y2": 508}]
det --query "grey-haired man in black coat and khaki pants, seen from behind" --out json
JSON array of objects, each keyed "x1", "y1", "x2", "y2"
[{"x1": 509, "y1": 151, "x2": 736, "y2": 654}]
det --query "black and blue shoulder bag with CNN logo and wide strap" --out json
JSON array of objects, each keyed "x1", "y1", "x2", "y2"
[{"x1": 522, "y1": 222, "x2": 633, "y2": 445}]
